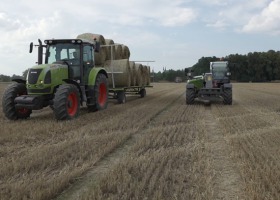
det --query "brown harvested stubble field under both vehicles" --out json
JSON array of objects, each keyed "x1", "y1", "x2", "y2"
[{"x1": 0, "y1": 83, "x2": 280, "y2": 200}]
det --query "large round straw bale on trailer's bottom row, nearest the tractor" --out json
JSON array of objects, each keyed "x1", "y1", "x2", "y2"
[{"x1": 104, "y1": 59, "x2": 131, "y2": 87}]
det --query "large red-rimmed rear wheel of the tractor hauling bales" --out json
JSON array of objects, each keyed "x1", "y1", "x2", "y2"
[{"x1": 88, "y1": 74, "x2": 108, "y2": 112}]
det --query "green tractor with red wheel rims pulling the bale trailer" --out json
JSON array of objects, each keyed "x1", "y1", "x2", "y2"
[{"x1": 2, "y1": 39, "x2": 109, "y2": 120}]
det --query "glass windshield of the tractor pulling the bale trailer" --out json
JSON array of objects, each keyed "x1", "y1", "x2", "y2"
[{"x1": 46, "y1": 43, "x2": 80, "y2": 65}]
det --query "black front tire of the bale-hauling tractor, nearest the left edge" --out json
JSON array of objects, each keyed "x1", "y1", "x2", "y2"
[{"x1": 2, "y1": 83, "x2": 32, "y2": 120}]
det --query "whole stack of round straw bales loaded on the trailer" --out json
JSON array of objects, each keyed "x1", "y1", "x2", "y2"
[{"x1": 77, "y1": 33, "x2": 150, "y2": 87}]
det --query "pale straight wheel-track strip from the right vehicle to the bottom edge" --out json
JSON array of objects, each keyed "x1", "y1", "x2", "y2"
[{"x1": 204, "y1": 105, "x2": 244, "y2": 199}]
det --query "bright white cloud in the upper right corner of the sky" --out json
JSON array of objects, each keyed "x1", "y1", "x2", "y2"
[{"x1": 242, "y1": 0, "x2": 280, "y2": 35}]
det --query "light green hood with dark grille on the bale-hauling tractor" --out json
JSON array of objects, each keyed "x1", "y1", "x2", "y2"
[{"x1": 26, "y1": 64, "x2": 68, "y2": 94}]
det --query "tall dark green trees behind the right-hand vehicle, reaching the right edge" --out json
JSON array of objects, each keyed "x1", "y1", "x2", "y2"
[{"x1": 192, "y1": 50, "x2": 280, "y2": 82}]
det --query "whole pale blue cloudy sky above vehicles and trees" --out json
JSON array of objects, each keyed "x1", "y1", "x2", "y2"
[{"x1": 0, "y1": 0, "x2": 280, "y2": 76}]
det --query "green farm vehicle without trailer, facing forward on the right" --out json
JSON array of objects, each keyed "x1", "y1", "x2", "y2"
[{"x1": 185, "y1": 61, "x2": 232, "y2": 105}]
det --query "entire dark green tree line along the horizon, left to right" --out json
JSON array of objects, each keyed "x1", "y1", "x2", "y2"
[{"x1": 0, "y1": 50, "x2": 280, "y2": 82}]
